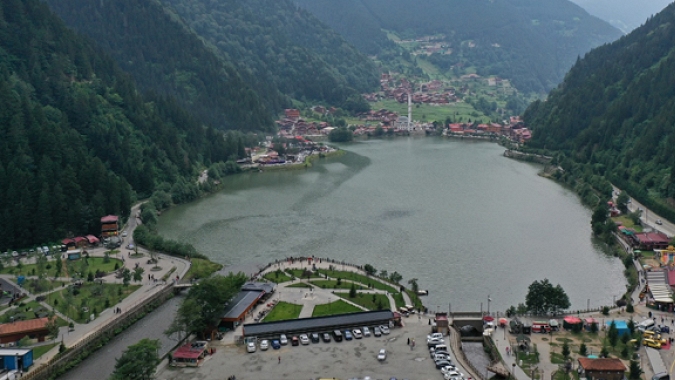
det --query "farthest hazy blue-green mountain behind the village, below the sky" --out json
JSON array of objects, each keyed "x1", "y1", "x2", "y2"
[{"x1": 295, "y1": 0, "x2": 621, "y2": 93}]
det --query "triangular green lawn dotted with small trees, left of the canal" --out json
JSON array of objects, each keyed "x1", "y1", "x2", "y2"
[{"x1": 46, "y1": 282, "x2": 140, "y2": 323}]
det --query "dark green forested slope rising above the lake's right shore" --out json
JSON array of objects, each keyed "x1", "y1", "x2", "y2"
[{"x1": 524, "y1": 4, "x2": 675, "y2": 219}]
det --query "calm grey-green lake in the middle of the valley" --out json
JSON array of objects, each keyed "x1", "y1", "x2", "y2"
[{"x1": 159, "y1": 138, "x2": 626, "y2": 311}]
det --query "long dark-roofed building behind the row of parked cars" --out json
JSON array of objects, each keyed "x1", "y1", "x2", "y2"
[{"x1": 244, "y1": 310, "x2": 394, "y2": 337}]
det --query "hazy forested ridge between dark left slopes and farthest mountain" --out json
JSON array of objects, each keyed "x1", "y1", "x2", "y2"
[{"x1": 158, "y1": 0, "x2": 379, "y2": 106}]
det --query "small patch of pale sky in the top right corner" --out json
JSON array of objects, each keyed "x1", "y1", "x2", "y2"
[{"x1": 571, "y1": 0, "x2": 673, "y2": 33}]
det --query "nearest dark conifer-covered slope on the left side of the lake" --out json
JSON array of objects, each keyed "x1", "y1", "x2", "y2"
[{"x1": 0, "y1": 0, "x2": 250, "y2": 251}]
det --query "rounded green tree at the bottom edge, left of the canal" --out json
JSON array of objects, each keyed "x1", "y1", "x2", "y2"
[{"x1": 111, "y1": 338, "x2": 161, "y2": 380}]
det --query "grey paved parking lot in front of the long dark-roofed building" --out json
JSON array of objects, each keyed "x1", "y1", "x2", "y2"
[{"x1": 157, "y1": 316, "x2": 454, "y2": 380}]
